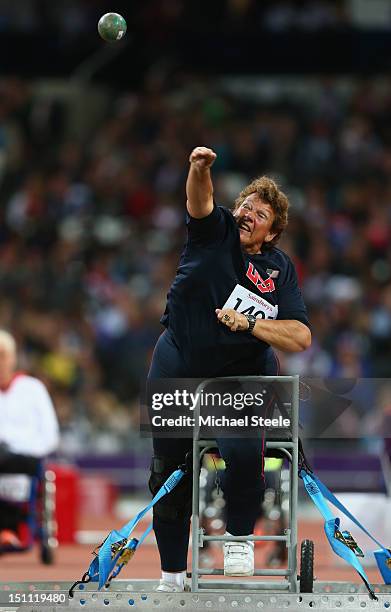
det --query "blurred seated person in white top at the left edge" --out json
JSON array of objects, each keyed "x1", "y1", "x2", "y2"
[{"x1": 0, "y1": 330, "x2": 59, "y2": 547}]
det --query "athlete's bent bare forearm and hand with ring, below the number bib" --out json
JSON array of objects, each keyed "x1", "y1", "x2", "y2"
[{"x1": 216, "y1": 308, "x2": 311, "y2": 353}]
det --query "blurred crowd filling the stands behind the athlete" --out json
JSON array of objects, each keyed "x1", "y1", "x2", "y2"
[{"x1": 0, "y1": 77, "x2": 391, "y2": 453}]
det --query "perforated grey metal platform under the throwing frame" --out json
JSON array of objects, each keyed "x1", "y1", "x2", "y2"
[{"x1": 0, "y1": 580, "x2": 391, "y2": 612}]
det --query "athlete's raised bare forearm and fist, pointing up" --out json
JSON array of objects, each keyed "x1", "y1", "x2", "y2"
[{"x1": 186, "y1": 147, "x2": 216, "y2": 219}]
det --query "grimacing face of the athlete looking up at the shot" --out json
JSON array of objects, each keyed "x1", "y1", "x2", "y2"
[{"x1": 234, "y1": 193, "x2": 276, "y2": 254}]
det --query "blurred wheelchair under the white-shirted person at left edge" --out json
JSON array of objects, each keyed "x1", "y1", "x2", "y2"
[{"x1": 0, "y1": 460, "x2": 58, "y2": 565}]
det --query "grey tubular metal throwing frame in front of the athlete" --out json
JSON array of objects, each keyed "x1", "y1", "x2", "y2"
[{"x1": 191, "y1": 376, "x2": 299, "y2": 593}]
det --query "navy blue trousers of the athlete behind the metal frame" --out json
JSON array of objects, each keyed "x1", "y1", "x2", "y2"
[{"x1": 148, "y1": 330, "x2": 278, "y2": 572}]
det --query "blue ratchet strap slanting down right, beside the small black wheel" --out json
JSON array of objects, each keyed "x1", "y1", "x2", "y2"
[{"x1": 299, "y1": 469, "x2": 391, "y2": 599}]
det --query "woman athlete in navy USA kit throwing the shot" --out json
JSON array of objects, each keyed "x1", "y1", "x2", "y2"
[{"x1": 148, "y1": 147, "x2": 311, "y2": 592}]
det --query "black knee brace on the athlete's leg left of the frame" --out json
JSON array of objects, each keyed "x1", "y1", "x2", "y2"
[{"x1": 148, "y1": 454, "x2": 193, "y2": 521}]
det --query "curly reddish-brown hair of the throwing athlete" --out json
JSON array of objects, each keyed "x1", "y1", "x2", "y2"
[{"x1": 234, "y1": 176, "x2": 289, "y2": 248}]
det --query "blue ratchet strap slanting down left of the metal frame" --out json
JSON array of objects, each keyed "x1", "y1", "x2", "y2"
[{"x1": 69, "y1": 468, "x2": 185, "y2": 597}]
